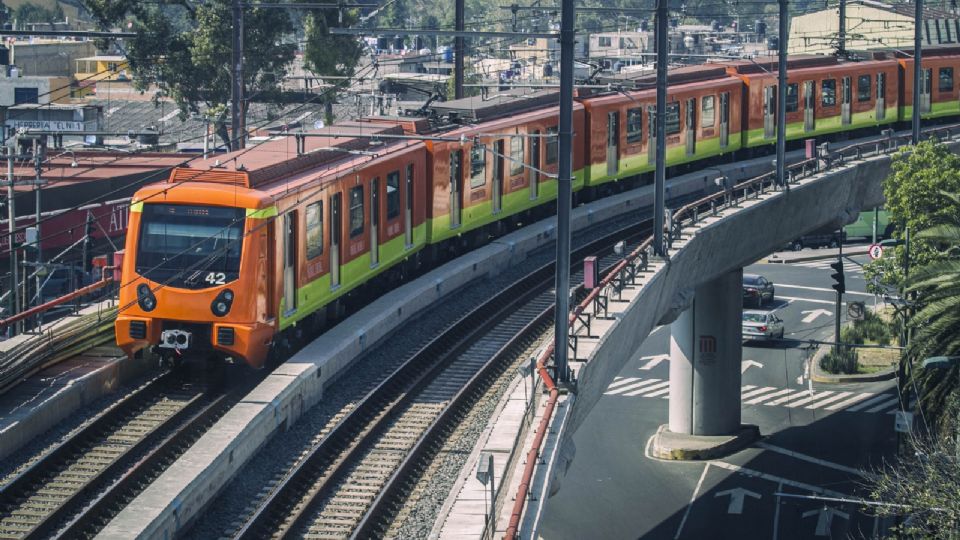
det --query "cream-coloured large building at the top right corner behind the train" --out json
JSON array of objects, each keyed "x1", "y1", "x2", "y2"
[{"x1": 788, "y1": 0, "x2": 960, "y2": 54}]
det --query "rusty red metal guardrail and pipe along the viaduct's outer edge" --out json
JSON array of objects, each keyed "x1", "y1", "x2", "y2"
[{"x1": 503, "y1": 124, "x2": 960, "y2": 540}]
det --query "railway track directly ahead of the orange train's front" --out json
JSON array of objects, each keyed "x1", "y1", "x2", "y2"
[{"x1": 0, "y1": 372, "x2": 236, "y2": 538}]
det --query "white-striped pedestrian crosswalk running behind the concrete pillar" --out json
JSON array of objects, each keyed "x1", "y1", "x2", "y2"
[{"x1": 604, "y1": 377, "x2": 900, "y2": 414}]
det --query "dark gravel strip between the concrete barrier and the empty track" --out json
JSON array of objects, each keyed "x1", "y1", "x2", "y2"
[{"x1": 184, "y1": 200, "x2": 668, "y2": 540}]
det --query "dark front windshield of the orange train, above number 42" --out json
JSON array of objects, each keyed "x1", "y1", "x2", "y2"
[{"x1": 137, "y1": 203, "x2": 246, "y2": 289}]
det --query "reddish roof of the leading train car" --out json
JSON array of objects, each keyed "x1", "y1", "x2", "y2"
[{"x1": 169, "y1": 122, "x2": 403, "y2": 188}]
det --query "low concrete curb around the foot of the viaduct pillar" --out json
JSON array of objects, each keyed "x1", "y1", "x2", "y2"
[{"x1": 650, "y1": 424, "x2": 760, "y2": 461}]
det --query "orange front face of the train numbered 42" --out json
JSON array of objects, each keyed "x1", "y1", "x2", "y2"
[{"x1": 115, "y1": 179, "x2": 276, "y2": 368}]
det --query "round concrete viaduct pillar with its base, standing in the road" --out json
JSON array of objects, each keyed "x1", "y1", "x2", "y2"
[{"x1": 653, "y1": 269, "x2": 759, "y2": 459}]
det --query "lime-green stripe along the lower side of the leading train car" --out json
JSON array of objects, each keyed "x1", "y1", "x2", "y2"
[{"x1": 280, "y1": 224, "x2": 427, "y2": 330}]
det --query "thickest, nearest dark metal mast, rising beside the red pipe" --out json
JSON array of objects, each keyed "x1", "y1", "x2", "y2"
[{"x1": 553, "y1": 0, "x2": 576, "y2": 382}]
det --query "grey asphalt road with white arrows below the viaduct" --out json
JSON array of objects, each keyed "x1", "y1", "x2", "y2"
[{"x1": 539, "y1": 256, "x2": 897, "y2": 539}]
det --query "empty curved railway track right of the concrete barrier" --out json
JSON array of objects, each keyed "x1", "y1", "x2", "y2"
[{"x1": 232, "y1": 217, "x2": 642, "y2": 538}]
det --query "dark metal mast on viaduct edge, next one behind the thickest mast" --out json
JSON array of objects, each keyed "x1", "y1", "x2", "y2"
[{"x1": 653, "y1": 0, "x2": 668, "y2": 256}]
